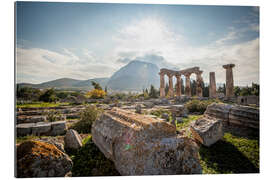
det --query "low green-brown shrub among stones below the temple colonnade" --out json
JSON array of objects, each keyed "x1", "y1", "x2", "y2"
[{"x1": 185, "y1": 99, "x2": 220, "y2": 114}]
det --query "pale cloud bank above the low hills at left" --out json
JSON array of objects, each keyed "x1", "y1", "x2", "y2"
[{"x1": 16, "y1": 47, "x2": 116, "y2": 83}]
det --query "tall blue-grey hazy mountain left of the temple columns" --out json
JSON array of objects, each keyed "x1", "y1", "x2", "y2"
[{"x1": 107, "y1": 60, "x2": 160, "y2": 91}]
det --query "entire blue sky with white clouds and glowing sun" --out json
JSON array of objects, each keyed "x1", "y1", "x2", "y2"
[{"x1": 16, "y1": 2, "x2": 259, "y2": 86}]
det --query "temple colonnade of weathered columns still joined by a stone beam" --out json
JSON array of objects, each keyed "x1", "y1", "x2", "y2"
[{"x1": 159, "y1": 67, "x2": 203, "y2": 98}]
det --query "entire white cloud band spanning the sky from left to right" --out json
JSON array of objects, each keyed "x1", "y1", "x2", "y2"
[{"x1": 16, "y1": 13, "x2": 259, "y2": 85}]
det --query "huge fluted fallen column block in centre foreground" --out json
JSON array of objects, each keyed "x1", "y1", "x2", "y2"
[{"x1": 91, "y1": 108, "x2": 202, "y2": 175}]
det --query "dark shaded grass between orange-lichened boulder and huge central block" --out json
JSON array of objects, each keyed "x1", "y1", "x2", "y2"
[{"x1": 69, "y1": 136, "x2": 120, "y2": 177}]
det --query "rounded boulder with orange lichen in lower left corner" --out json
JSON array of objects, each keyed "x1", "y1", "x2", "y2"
[{"x1": 16, "y1": 141, "x2": 73, "y2": 178}]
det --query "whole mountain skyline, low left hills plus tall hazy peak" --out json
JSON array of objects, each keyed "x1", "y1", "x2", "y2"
[{"x1": 18, "y1": 60, "x2": 159, "y2": 91}]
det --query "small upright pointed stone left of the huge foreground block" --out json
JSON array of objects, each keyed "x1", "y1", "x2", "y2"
[{"x1": 64, "y1": 129, "x2": 82, "y2": 149}]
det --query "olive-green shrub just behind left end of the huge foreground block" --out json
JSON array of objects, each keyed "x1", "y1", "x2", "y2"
[{"x1": 72, "y1": 105, "x2": 101, "y2": 133}]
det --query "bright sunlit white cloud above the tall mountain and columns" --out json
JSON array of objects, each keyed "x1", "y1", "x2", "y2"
[{"x1": 114, "y1": 19, "x2": 259, "y2": 85}]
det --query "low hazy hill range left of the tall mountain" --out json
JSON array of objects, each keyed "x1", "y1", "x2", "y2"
[{"x1": 18, "y1": 78, "x2": 109, "y2": 90}]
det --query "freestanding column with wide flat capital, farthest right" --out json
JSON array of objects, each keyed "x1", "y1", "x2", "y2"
[{"x1": 223, "y1": 64, "x2": 235, "y2": 97}]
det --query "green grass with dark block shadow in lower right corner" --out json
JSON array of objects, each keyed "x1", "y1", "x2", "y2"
[{"x1": 199, "y1": 133, "x2": 259, "y2": 174}]
